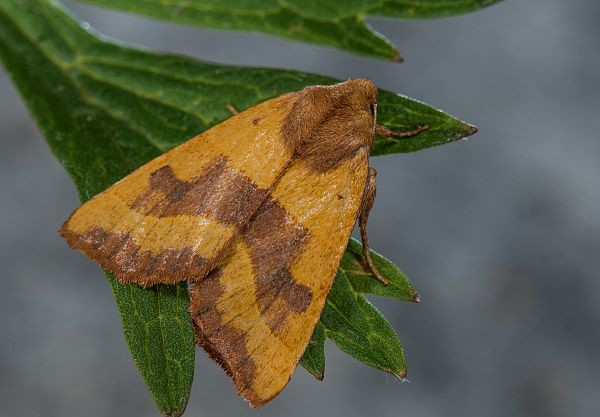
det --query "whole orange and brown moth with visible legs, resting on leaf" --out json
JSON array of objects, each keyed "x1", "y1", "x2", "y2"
[{"x1": 61, "y1": 79, "x2": 427, "y2": 407}]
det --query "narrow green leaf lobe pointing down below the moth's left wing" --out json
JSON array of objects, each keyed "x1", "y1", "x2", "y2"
[{"x1": 106, "y1": 273, "x2": 195, "y2": 416}]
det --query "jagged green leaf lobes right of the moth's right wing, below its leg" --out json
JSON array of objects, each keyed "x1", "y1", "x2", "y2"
[{"x1": 300, "y1": 239, "x2": 419, "y2": 380}]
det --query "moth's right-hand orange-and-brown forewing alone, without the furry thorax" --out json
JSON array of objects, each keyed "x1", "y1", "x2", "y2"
[{"x1": 190, "y1": 148, "x2": 368, "y2": 406}]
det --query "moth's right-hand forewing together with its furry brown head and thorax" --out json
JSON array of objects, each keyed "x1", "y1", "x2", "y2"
[{"x1": 190, "y1": 80, "x2": 376, "y2": 406}]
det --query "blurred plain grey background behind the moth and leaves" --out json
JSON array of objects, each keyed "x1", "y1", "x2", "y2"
[{"x1": 0, "y1": 0, "x2": 600, "y2": 417}]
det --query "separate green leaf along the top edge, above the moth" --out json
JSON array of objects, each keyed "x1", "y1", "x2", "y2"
[{"x1": 80, "y1": 0, "x2": 501, "y2": 61}]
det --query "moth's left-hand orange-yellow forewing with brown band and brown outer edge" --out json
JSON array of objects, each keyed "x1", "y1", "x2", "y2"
[{"x1": 61, "y1": 95, "x2": 294, "y2": 286}]
